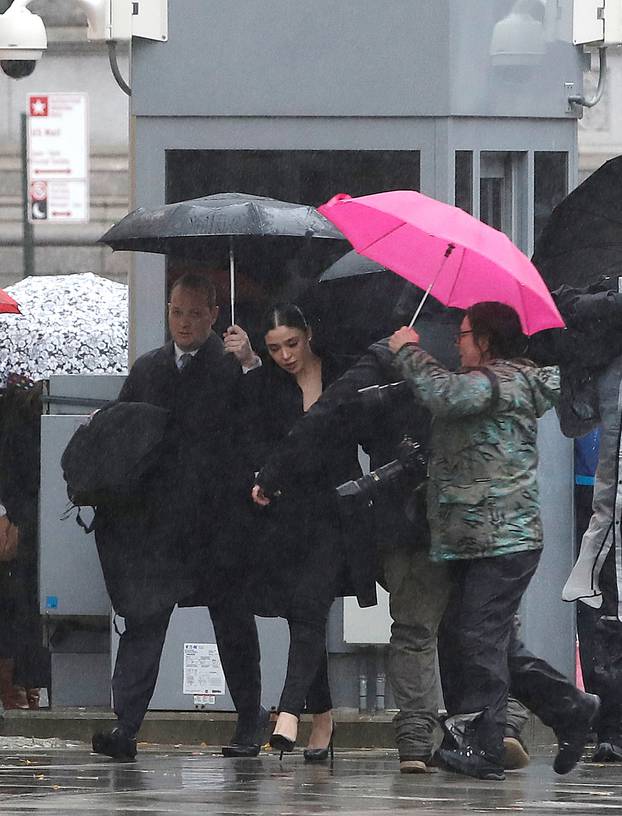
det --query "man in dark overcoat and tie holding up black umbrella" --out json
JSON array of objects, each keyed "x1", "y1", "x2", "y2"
[{"x1": 93, "y1": 273, "x2": 268, "y2": 759}]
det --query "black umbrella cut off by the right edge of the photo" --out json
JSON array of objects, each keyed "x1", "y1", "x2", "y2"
[{"x1": 532, "y1": 156, "x2": 622, "y2": 290}]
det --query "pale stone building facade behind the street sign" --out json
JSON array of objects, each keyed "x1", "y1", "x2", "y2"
[{"x1": 0, "y1": 0, "x2": 130, "y2": 287}]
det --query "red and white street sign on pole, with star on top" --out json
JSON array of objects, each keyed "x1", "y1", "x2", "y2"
[{"x1": 28, "y1": 93, "x2": 89, "y2": 223}]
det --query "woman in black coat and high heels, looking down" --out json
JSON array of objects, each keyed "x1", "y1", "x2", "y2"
[{"x1": 243, "y1": 304, "x2": 376, "y2": 761}]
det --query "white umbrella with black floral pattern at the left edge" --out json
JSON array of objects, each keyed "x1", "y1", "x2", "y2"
[{"x1": 0, "y1": 272, "x2": 128, "y2": 380}]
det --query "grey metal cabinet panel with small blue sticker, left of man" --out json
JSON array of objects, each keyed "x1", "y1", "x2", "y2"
[{"x1": 39, "y1": 415, "x2": 110, "y2": 617}]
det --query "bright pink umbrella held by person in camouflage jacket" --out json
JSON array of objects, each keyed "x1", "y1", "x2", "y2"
[{"x1": 318, "y1": 190, "x2": 564, "y2": 334}]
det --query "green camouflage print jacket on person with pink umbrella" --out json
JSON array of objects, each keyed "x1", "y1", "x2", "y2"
[{"x1": 396, "y1": 345, "x2": 559, "y2": 561}]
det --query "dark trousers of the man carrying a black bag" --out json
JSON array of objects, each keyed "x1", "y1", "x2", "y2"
[{"x1": 112, "y1": 602, "x2": 261, "y2": 744}]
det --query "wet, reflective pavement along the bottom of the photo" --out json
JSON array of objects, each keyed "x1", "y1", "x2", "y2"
[{"x1": 0, "y1": 745, "x2": 622, "y2": 816}]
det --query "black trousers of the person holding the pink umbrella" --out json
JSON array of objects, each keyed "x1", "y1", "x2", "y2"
[{"x1": 441, "y1": 550, "x2": 581, "y2": 755}]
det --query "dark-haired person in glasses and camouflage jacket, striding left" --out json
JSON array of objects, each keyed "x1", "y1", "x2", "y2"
[{"x1": 389, "y1": 302, "x2": 598, "y2": 779}]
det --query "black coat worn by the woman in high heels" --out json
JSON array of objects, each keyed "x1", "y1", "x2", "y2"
[{"x1": 242, "y1": 355, "x2": 376, "y2": 617}]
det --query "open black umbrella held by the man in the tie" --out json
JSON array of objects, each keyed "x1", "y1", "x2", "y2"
[{"x1": 99, "y1": 193, "x2": 345, "y2": 323}]
